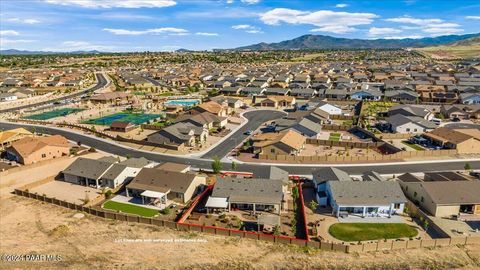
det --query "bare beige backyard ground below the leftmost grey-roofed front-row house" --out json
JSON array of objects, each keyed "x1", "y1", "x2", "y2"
[{"x1": 30, "y1": 181, "x2": 102, "y2": 204}]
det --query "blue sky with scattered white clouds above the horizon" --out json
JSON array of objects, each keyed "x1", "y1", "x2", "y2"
[{"x1": 0, "y1": 0, "x2": 480, "y2": 52}]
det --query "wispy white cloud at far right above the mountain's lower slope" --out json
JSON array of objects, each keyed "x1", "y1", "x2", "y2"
[{"x1": 386, "y1": 17, "x2": 463, "y2": 36}]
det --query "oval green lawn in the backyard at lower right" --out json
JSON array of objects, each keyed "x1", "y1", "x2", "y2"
[{"x1": 328, "y1": 223, "x2": 418, "y2": 242}]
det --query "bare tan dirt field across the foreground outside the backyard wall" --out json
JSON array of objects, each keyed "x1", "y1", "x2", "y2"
[{"x1": 0, "y1": 196, "x2": 480, "y2": 269}]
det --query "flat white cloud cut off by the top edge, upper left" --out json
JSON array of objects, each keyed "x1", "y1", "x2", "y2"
[{"x1": 45, "y1": 0, "x2": 177, "y2": 8}]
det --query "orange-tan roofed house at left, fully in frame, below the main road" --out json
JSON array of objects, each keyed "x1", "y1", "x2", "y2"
[{"x1": 6, "y1": 135, "x2": 71, "y2": 165}]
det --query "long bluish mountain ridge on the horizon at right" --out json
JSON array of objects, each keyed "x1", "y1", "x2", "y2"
[{"x1": 235, "y1": 33, "x2": 480, "y2": 51}]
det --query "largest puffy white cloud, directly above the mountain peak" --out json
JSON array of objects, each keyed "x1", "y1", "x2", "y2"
[{"x1": 260, "y1": 8, "x2": 378, "y2": 33}]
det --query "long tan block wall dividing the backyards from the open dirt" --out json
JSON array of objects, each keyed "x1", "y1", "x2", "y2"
[{"x1": 14, "y1": 189, "x2": 480, "y2": 253}]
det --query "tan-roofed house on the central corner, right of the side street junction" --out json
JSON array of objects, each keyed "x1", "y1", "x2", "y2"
[{"x1": 253, "y1": 130, "x2": 306, "y2": 155}]
